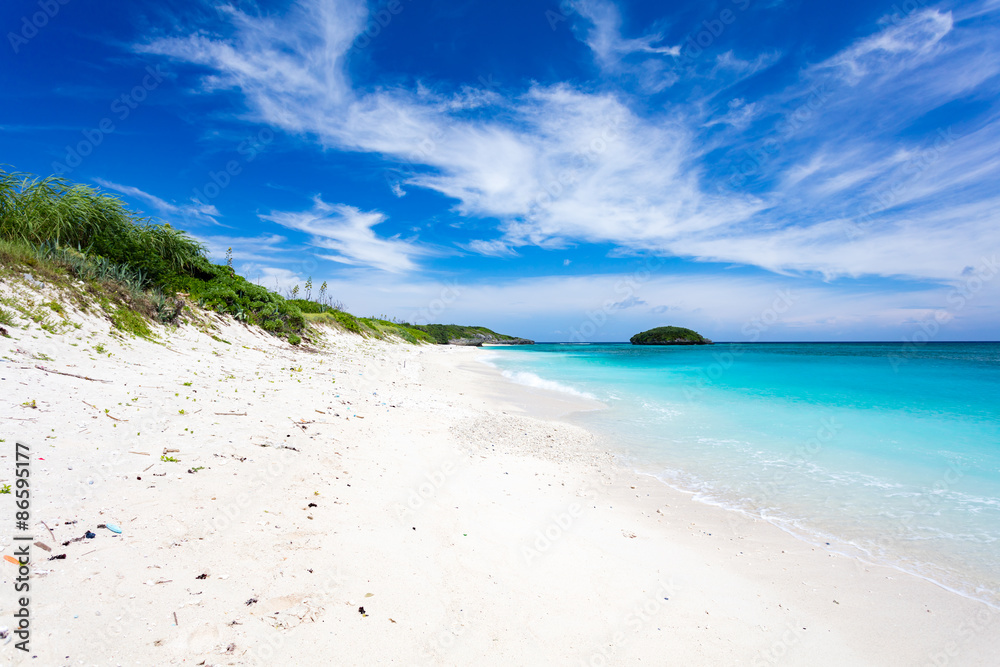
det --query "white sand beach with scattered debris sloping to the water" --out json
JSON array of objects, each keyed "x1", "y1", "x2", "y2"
[{"x1": 0, "y1": 284, "x2": 1000, "y2": 665}]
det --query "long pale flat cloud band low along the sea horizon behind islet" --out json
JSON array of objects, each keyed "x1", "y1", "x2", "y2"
[{"x1": 300, "y1": 260, "x2": 1000, "y2": 341}]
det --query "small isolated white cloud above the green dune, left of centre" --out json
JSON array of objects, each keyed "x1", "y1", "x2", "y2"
[{"x1": 260, "y1": 197, "x2": 433, "y2": 273}]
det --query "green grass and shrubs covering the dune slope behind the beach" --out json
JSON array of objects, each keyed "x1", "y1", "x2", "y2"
[{"x1": 0, "y1": 169, "x2": 529, "y2": 353}]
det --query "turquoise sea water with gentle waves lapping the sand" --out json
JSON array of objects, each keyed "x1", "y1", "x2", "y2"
[{"x1": 489, "y1": 343, "x2": 1000, "y2": 605}]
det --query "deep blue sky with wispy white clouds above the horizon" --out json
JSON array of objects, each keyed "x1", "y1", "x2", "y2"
[{"x1": 0, "y1": 0, "x2": 1000, "y2": 343}]
